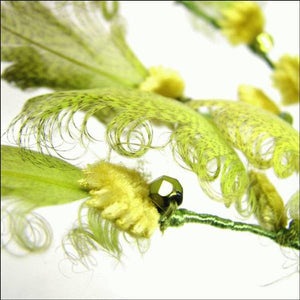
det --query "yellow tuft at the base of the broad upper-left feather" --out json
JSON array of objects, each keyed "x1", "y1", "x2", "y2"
[{"x1": 139, "y1": 66, "x2": 184, "y2": 98}]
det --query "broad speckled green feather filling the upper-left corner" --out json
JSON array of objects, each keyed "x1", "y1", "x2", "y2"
[{"x1": 1, "y1": 1, "x2": 147, "y2": 90}]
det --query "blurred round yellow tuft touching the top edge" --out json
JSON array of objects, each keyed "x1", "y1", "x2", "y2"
[{"x1": 219, "y1": 1, "x2": 264, "y2": 45}]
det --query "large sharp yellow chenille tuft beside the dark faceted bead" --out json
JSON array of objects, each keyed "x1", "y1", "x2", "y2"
[{"x1": 80, "y1": 161, "x2": 160, "y2": 238}]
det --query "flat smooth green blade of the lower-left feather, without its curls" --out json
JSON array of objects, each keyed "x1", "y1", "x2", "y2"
[{"x1": 1, "y1": 146, "x2": 89, "y2": 208}]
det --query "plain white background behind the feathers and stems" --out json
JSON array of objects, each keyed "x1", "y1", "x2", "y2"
[{"x1": 1, "y1": 1, "x2": 299, "y2": 299}]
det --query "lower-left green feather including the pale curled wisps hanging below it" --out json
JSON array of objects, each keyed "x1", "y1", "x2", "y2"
[{"x1": 1, "y1": 146, "x2": 89, "y2": 255}]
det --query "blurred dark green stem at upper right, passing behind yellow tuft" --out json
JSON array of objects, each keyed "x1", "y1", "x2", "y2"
[{"x1": 175, "y1": 1, "x2": 275, "y2": 69}]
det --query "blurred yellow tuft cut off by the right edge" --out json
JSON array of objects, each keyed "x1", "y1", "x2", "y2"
[{"x1": 272, "y1": 55, "x2": 299, "y2": 105}]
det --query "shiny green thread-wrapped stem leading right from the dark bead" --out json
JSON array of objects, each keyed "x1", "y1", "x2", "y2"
[{"x1": 165, "y1": 208, "x2": 300, "y2": 250}]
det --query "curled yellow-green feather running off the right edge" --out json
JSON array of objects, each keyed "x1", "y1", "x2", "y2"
[{"x1": 188, "y1": 100, "x2": 299, "y2": 178}]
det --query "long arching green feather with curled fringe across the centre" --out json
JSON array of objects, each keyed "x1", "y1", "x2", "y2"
[{"x1": 11, "y1": 88, "x2": 248, "y2": 205}]
